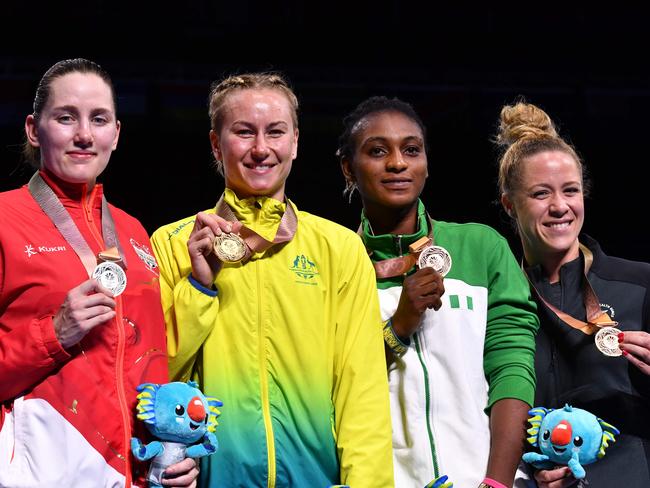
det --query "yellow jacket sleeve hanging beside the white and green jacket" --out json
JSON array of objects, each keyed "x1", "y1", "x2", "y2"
[{"x1": 333, "y1": 234, "x2": 393, "y2": 488}]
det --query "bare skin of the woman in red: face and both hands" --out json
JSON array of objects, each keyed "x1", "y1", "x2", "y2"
[{"x1": 25, "y1": 72, "x2": 199, "y2": 488}]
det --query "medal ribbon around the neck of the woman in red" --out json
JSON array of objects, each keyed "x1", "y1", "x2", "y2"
[{"x1": 27, "y1": 172, "x2": 126, "y2": 277}]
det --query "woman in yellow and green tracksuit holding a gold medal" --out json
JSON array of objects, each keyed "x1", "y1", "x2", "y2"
[{"x1": 152, "y1": 74, "x2": 393, "y2": 488}]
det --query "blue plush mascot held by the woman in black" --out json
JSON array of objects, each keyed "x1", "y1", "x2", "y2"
[{"x1": 523, "y1": 405, "x2": 620, "y2": 479}]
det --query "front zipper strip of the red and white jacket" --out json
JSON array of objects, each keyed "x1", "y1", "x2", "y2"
[{"x1": 81, "y1": 186, "x2": 131, "y2": 488}]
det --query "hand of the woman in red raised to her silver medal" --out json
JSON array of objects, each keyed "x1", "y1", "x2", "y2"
[{"x1": 53, "y1": 278, "x2": 115, "y2": 348}]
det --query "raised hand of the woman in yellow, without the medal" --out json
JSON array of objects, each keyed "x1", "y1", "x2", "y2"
[{"x1": 187, "y1": 212, "x2": 242, "y2": 288}]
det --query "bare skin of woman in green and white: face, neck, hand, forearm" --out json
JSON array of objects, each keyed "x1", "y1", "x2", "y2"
[{"x1": 341, "y1": 112, "x2": 530, "y2": 486}]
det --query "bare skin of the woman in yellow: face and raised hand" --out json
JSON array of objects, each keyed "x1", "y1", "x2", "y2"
[{"x1": 187, "y1": 88, "x2": 298, "y2": 288}]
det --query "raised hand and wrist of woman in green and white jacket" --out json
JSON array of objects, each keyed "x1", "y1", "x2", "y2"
[{"x1": 392, "y1": 268, "x2": 445, "y2": 337}]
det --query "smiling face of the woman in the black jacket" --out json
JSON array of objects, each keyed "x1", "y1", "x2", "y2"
[{"x1": 502, "y1": 151, "x2": 584, "y2": 274}]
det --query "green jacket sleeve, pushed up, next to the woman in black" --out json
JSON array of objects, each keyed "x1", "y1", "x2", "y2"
[{"x1": 484, "y1": 236, "x2": 539, "y2": 410}]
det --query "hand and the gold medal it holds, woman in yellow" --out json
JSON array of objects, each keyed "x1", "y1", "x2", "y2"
[{"x1": 187, "y1": 212, "x2": 246, "y2": 288}]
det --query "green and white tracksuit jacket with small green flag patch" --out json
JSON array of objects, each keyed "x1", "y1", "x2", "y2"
[{"x1": 362, "y1": 202, "x2": 538, "y2": 488}]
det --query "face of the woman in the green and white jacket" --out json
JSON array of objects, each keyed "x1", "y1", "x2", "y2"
[{"x1": 341, "y1": 111, "x2": 428, "y2": 213}]
